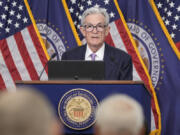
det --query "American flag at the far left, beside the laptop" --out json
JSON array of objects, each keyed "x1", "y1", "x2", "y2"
[{"x1": 0, "y1": 0, "x2": 47, "y2": 89}]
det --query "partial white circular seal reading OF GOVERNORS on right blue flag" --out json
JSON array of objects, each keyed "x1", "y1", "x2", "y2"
[{"x1": 127, "y1": 23, "x2": 161, "y2": 87}]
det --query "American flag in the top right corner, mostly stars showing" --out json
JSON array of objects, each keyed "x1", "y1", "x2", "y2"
[{"x1": 155, "y1": 0, "x2": 180, "y2": 51}]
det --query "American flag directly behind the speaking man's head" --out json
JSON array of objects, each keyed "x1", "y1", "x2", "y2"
[{"x1": 63, "y1": 0, "x2": 158, "y2": 130}]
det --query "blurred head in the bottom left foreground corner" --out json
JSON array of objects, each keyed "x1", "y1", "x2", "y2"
[{"x1": 0, "y1": 88, "x2": 60, "y2": 135}]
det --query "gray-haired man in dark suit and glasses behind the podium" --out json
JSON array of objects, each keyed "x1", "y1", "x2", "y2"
[{"x1": 62, "y1": 7, "x2": 132, "y2": 80}]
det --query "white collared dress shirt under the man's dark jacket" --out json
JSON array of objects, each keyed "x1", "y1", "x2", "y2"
[{"x1": 85, "y1": 44, "x2": 105, "y2": 61}]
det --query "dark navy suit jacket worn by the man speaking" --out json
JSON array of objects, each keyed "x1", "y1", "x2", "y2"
[{"x1": 62, "y1": 44, "x2": 132, "y2": 80}]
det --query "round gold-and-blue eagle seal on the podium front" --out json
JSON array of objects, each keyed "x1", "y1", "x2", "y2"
[{"x1": 58, "y1": 88, "x2": 98, "y2": 130}]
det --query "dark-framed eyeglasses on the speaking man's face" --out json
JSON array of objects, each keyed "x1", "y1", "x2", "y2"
[{"x1": 83, "y1": 24, "x2": 107, "y2": 32}]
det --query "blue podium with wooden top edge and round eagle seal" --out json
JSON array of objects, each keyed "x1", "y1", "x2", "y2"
[{"x1": 16, "y1": 80, "x2": 151, "y2": 134}]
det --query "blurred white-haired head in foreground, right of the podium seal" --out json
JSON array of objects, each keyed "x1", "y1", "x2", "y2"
[{"x1": 96, "y1": 94, "x2": 144, "y2": 135}]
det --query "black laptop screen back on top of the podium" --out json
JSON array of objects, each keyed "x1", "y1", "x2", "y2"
[{"x1": 48, "y1": 60, "x2": 105, "y2": 80}]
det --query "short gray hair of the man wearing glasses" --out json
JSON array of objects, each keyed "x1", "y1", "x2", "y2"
[{"x1": 81, "y1": 7, "x2": 109, "y2": 26}]
